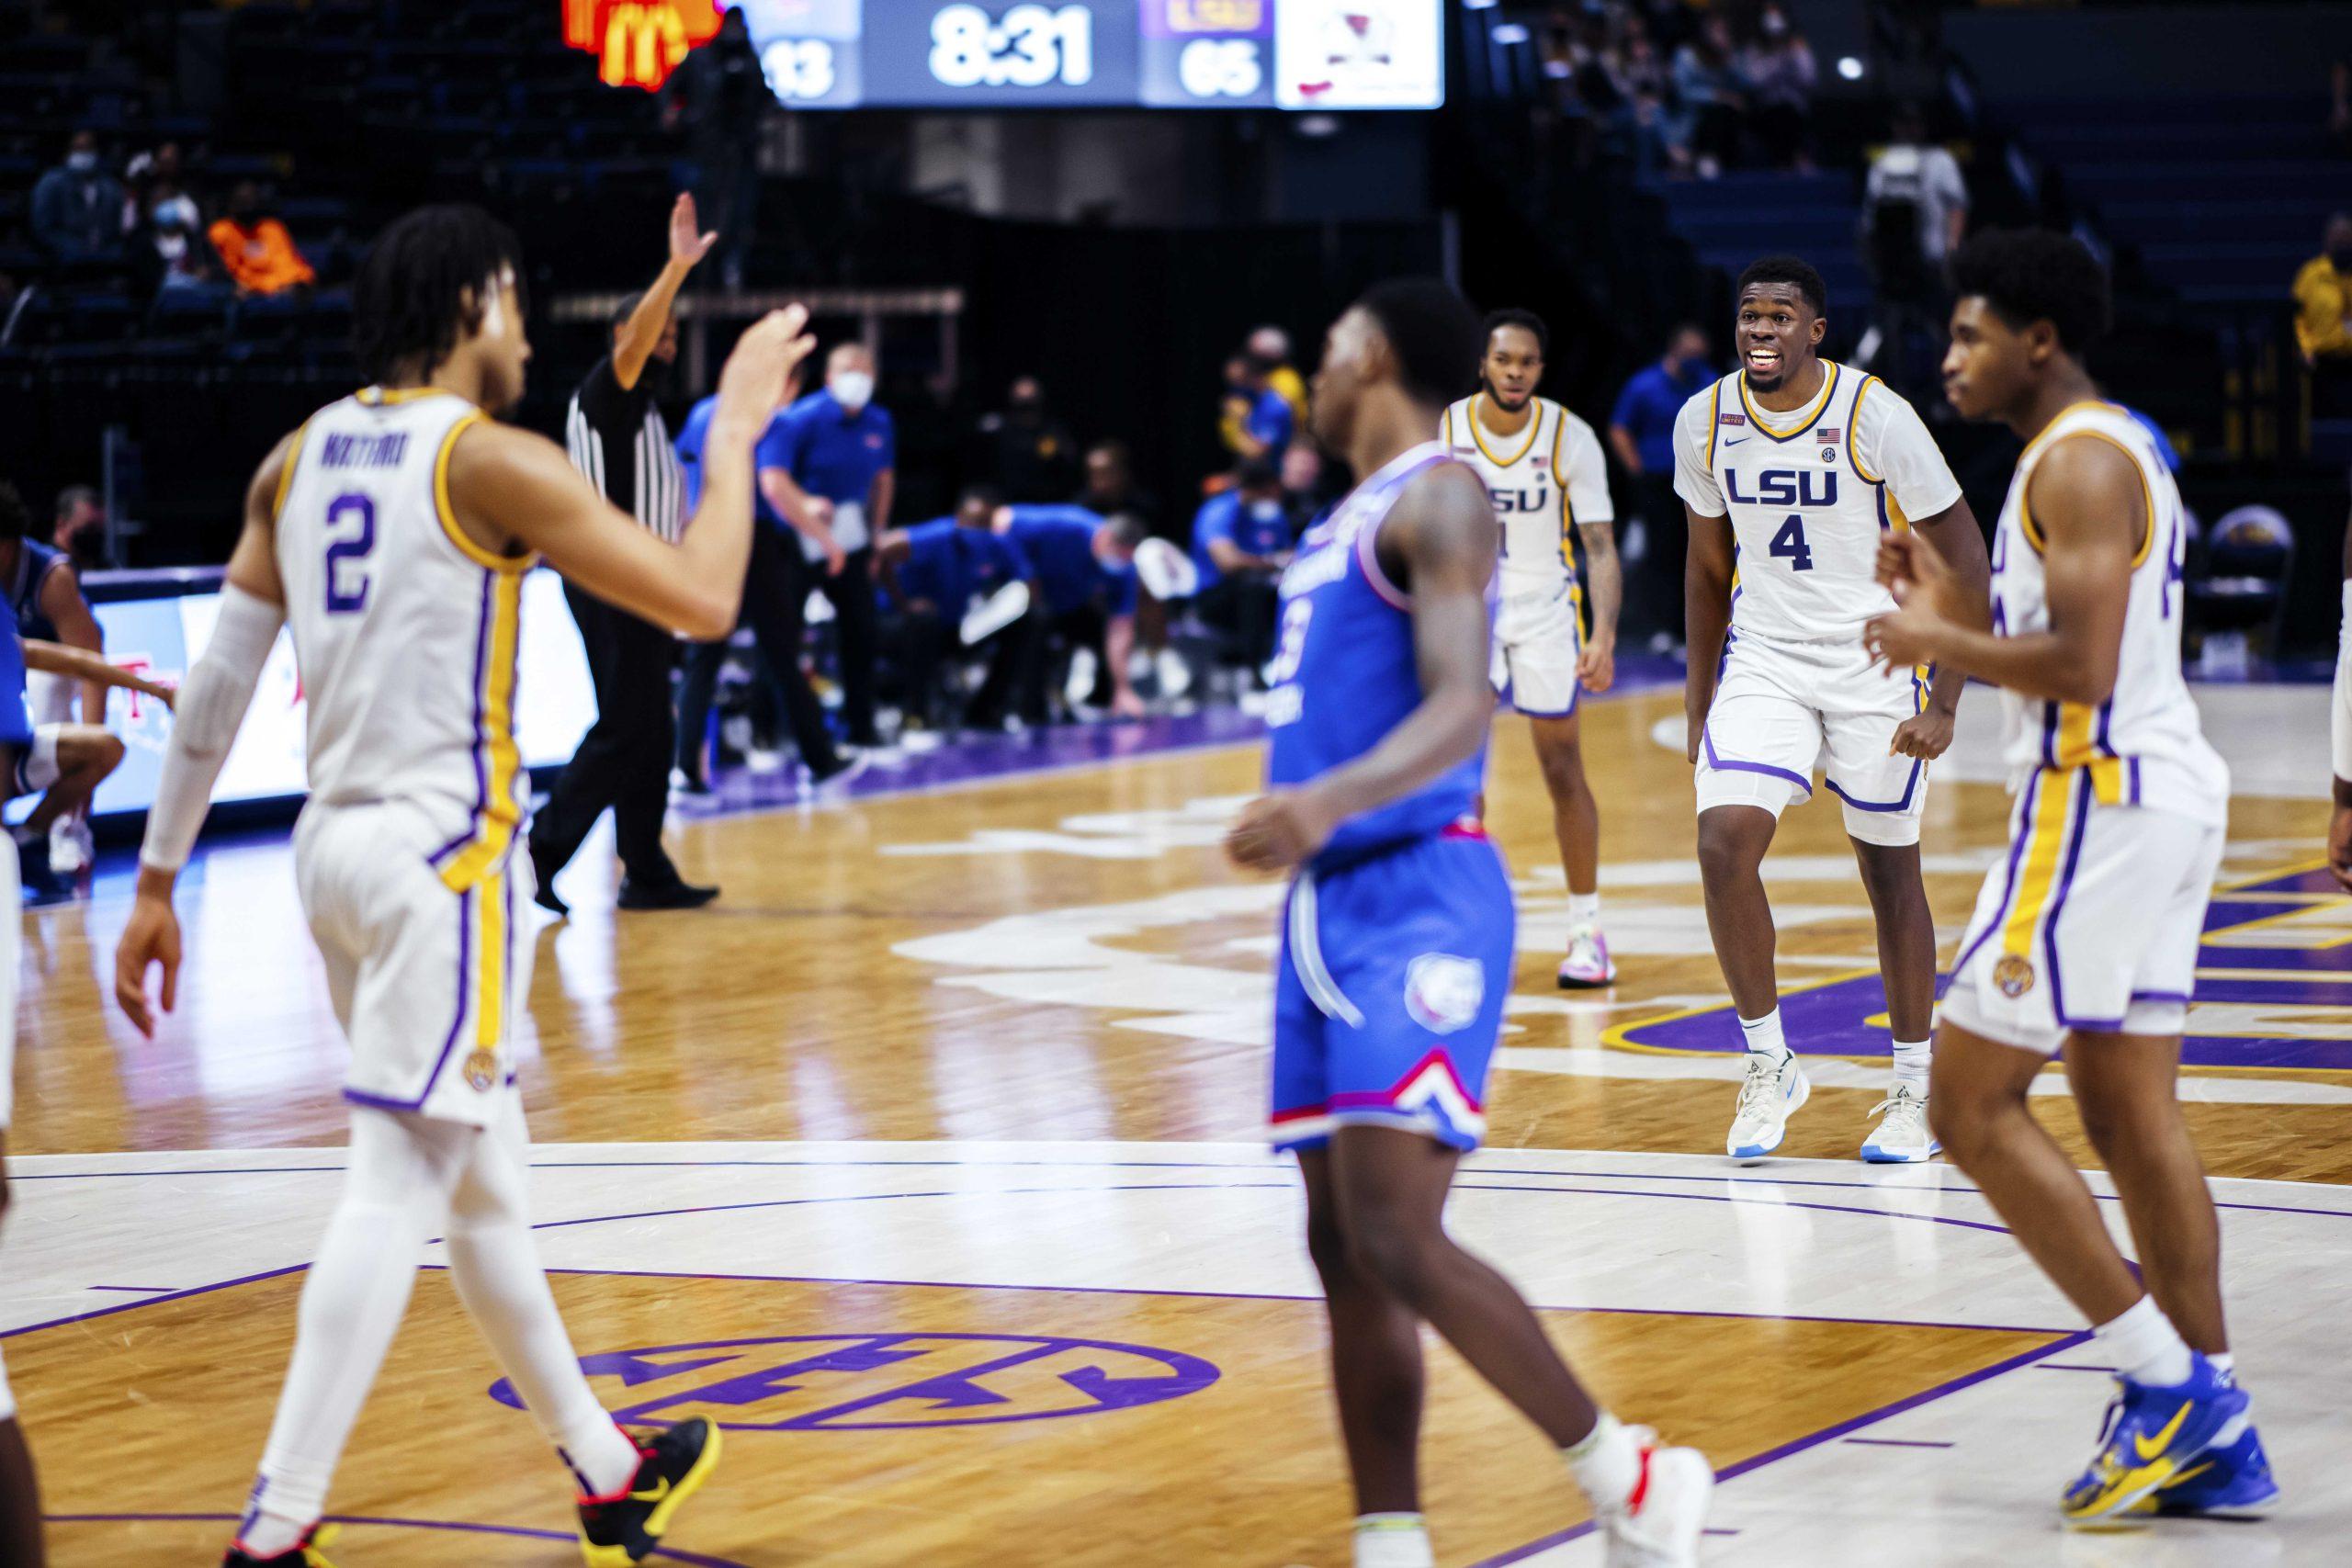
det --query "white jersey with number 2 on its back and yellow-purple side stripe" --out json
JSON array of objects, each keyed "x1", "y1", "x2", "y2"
[{"x1": 277, "y1": 388, "x2": 532, "y2": 888}]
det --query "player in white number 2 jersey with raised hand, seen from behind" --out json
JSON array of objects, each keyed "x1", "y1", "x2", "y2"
[{"x1": 115, "y1": 207, "x2": 811, "y2": 1568}]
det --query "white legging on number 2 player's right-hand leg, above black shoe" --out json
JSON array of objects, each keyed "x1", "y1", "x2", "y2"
[{"x1": 447, "y1": 1090, "x2": 639, "y2": 1497}]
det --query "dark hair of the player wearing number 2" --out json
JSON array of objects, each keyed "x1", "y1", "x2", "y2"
[{"x1": 350, "y1": 205, "x2": 522, "y2": 381}]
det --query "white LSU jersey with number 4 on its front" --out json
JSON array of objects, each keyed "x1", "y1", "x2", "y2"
[{"x1": 1675, "y1": 360, "x2": 1959, "y2": 642}]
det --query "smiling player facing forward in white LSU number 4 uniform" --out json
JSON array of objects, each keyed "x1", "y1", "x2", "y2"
[{"x1": 1675, "y1": 256, "x2": 1985, "y2": 1164}]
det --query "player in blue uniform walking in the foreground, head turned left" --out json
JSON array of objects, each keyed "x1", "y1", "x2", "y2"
[{"x1": 1226, "y1": 280, "x2": 1714, "y2": 1568}]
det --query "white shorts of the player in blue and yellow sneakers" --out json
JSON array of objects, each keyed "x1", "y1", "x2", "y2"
[{"x1": 1943, "y1": 769, "x2": 2227, "y2": 1055}]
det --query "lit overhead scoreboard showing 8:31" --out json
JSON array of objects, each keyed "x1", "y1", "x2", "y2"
[{"x1": 722, "y1": 0, "x2": 1444, "y2": 110}]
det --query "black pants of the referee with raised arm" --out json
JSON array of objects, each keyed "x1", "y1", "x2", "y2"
[{"x1": 532, "y1": 583, "x2": 677, "y2": 886}]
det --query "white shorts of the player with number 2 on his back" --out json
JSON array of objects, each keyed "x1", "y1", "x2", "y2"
[{"x1": 294, "y1": 802, "x2": 537, "y2": 1126}]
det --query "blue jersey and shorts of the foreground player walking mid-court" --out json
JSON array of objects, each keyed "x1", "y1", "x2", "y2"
[{"x1": 1265, "y1": 442, "x2": 1517, "y2": 1149}]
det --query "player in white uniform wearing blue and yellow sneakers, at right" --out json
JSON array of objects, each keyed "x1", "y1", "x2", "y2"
[{"x1": 1868, "y1": 231, "x2": 2279, "y2": 1523}]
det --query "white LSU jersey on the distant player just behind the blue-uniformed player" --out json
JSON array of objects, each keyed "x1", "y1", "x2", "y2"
[{"x1": 1440, "y1": 392, "x2": 1616, "y2": 581}]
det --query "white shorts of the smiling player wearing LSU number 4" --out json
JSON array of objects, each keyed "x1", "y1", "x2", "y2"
[{"x1": 1698, "y1": 632, "x2": 1927, "y2": 846}]
